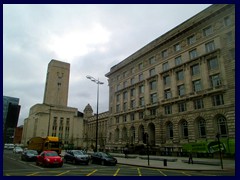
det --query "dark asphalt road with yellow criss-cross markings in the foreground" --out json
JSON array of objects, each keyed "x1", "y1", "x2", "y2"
[{"x1": 3, "y1": 150, "x2": 235, "y2": 176}]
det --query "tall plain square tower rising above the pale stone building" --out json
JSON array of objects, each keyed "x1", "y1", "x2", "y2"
[{"x1": 43, "y1": 59, "x2": 70, "y2": 106}]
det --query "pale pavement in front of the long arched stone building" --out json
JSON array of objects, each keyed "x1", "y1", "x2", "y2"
[{"x1": 62, "y1": 152, "x2": 235, "y2": 171}]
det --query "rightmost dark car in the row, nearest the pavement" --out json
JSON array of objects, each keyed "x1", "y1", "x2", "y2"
[{"x1": 91, "y1": 152, "x2": 117, "y2": 166}]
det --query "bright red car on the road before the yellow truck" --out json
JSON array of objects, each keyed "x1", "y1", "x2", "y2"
[{"x1": 36, "y1": 151, "x2": 63, "y2": 167}]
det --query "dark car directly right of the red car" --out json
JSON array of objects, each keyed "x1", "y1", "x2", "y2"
[{"x1": 64, "y1": 150, "x2": 90, "y2": 164}]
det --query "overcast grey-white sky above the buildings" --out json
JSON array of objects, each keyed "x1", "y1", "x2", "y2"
[{"x1": 3, "y1": 4, "x2": 210, "y2": 126}]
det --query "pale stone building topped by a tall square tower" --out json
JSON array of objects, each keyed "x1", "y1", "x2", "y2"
[{"x1": 22, "y1": 60, "x2": 83, "y2": 148}]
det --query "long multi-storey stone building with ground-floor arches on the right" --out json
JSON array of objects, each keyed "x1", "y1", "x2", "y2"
[{"x1": 106, "y1": 4, "x2": 235, "y2": 152}]
